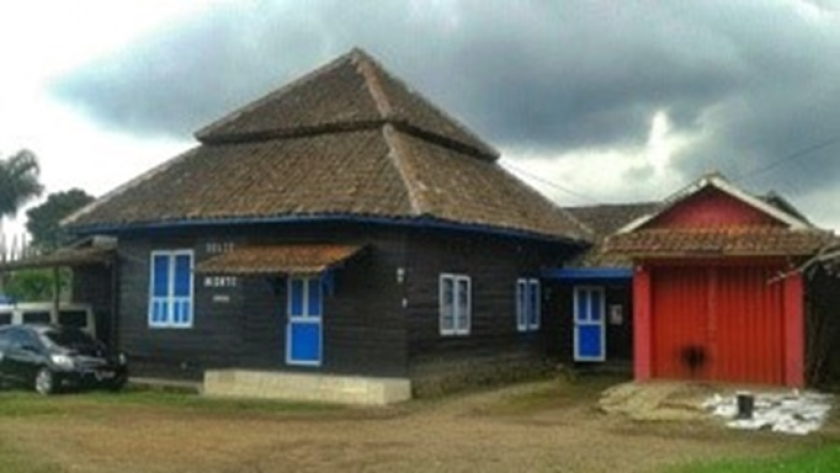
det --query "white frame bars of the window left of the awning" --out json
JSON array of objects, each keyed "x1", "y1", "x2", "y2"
[{"x1": 147, "y1": 250, "x2": 195, "y2": 328}]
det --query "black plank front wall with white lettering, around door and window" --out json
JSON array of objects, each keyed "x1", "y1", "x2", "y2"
[{"x1": 119, "y1": 225, "x2": 407, "y2": 377}]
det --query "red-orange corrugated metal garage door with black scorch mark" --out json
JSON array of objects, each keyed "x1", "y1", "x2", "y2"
[{"x1": 651, "y1": 266, "x2": 784, "y2": 384}]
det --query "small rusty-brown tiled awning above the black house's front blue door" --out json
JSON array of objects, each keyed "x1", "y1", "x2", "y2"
[{"x1": 195, "y1": 244, "x2": 364, "y2": 275}]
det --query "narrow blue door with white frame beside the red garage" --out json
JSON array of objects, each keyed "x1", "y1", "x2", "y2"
[{"x1": 574, "y1": 286, "x2": 607, "y2": 361}]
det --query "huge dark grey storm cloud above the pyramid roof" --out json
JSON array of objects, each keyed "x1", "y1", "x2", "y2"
[{"x1": 54, "y1": 0, "x2": 840, "y2": 196}]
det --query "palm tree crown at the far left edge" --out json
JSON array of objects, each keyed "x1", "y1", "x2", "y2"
[{"x1": 0, "y1": 150, "x2": 43, "y2": 220}]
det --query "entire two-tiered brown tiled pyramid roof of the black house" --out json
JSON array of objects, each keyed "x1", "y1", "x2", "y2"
[{"x1": 65, "y1": 50, "x2": 587, "y2": 240}]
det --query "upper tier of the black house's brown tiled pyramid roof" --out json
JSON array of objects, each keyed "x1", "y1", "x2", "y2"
[{"x1": 196, "y1": 49, "x2": 499, "y2": 160}]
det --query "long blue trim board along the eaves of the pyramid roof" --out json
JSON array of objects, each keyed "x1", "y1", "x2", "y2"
[{"x1": 68, "y1": 214, "x2": 590, "y2": 247}]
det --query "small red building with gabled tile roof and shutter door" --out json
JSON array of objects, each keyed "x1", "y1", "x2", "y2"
[{"x1": 605, "y1": 175, "x2": 832, "y2": 386}]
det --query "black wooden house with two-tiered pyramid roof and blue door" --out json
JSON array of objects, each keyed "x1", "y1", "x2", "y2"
[{"x1": 65, "y1": 50, "x2": 588, "y2": 402}]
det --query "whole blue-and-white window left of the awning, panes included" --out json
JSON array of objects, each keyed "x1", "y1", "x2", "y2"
[{"x1": 149, "y1": 250, "x2": 193, "y2": 328}]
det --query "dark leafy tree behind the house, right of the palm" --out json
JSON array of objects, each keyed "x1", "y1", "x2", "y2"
[{"x1": 26, "y1": 189, "x2": 93, "y2": 253}]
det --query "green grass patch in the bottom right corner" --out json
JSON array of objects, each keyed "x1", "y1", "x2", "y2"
[{"x1": 666, "y1": 444, "x2": 840, "y2": 473}]
